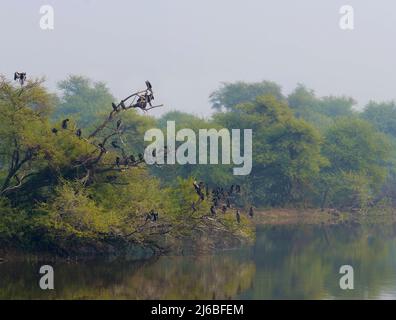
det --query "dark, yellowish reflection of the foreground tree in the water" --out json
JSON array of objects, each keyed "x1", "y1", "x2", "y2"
[{"x1": 0, "y1": 256, "x2": 255, "y2": 299}]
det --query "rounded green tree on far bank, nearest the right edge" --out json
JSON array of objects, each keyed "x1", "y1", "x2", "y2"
[{"x1": 319, "y1": 118, "x2": 390, "y2": 208}]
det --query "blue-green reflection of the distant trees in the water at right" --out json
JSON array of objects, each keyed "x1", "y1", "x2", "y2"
[{"x1": 245, "y1": 226, "x2": 396, "y2": 299}]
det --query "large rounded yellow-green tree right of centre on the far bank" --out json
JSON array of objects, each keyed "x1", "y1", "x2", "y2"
[{"x1": 215, "y1": 95, "x2": 325, "y2": 205}]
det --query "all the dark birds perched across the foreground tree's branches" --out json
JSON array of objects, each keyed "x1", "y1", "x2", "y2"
[{"x1": 14, "y1": 72, "x2": 254, "y2": 223}]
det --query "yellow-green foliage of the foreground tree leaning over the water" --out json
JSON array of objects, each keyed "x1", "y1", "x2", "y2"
[{"x1": 0, "y1": 77, "x2": 252, "y2": 254}]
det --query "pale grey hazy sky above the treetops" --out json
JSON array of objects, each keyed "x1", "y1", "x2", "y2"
[{"x1": 0, "y1": 0, "x2": 396, "y2": 116}]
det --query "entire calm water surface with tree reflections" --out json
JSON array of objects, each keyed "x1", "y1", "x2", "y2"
[{"x1": 0, "y1": 225, "x2": 396, "y2": 299}]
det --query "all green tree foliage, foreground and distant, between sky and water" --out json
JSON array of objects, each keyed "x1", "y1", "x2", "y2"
[{"x1": 0, "y1": 76, "x2": 396, "y2": 254}]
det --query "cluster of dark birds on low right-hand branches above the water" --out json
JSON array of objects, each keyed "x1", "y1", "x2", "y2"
[{"x1": 191, "y1": 181, "x2": 254, "y2": 223}]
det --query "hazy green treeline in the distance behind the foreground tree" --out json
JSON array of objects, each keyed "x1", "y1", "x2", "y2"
[{"x1": 48, "y1": 77, "x2": 396, "y2": 210}]
